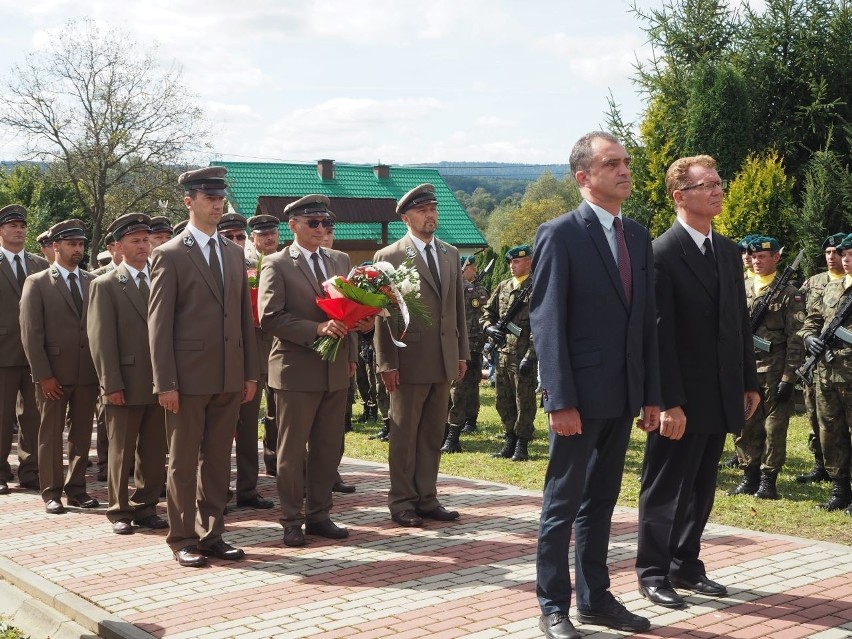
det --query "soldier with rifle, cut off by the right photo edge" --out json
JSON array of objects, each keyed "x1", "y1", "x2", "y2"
[{"x1": 799, "y1": 234, "x2": 852, "y2": 514}]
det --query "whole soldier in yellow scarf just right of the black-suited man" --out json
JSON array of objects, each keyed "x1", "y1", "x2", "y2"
[{"x1": 728, "y1": 236, "x2": 805, "y2": 499}]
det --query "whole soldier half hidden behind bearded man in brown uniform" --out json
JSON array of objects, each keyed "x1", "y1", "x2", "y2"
[{"x1": 441, "y1": 255, "x2": 488, "y2": 453}]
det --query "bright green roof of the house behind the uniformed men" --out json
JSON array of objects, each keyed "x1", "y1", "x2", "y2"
[{"x1": 211, "y1": 162, "x2": 486, "y2": 247}]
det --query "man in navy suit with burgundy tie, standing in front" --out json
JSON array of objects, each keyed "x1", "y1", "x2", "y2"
[{"x1": 530, "y1": 131, "x2": 660, "y2": 639}]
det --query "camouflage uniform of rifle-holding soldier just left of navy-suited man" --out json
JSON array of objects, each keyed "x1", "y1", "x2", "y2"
[{"x1": 482, "y1": 277, "x2": 538, "y2": 440}]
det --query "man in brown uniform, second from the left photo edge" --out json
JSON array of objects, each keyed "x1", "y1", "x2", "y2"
[{"x1": 21, "y1": 220, "x2": 99, "y2": 515}]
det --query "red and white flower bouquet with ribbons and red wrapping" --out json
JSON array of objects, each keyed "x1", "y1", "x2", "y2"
[{"x1": 313, "y1": 260, "x2": 430, "y2": 362}]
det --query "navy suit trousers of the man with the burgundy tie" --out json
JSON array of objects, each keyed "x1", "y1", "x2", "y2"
[{"x1": 540, "y1": 415, "x2": 632, "y2": 615}]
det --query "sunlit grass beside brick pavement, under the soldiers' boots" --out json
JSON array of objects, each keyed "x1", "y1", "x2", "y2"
[{"x1": 345, "y1": 385, "x2": 852, "y2": 545}]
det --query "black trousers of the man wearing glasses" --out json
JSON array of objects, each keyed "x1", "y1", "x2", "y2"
[{"x1": 636, "y1": 426, "x2": 725, "y2": 587}]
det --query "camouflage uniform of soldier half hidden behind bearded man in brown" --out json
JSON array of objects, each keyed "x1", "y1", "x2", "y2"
[{"x1": 450, "y1": 282, "x2": 488, "y2": 425}]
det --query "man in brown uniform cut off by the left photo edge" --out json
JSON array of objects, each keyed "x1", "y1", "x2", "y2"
[{"x1": 0, "y1": 204, "x2": 48, "y2": 495}]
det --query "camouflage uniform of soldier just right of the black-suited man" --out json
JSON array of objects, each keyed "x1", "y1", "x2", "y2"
[{"x1": 735, "y1": 276, "x2": 805, "y2": 475}]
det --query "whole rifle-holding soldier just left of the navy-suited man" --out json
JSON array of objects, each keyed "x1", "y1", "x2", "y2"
[{"x1": 482, "y1": 244, "x2": 538, "y2": 461}]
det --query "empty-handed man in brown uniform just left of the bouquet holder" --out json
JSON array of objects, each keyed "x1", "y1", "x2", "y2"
[{"x1": 148, "y1": 166, "x2": 260, "y2": 567}]
